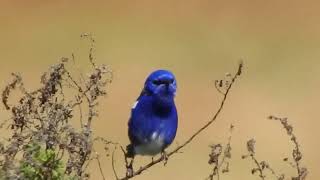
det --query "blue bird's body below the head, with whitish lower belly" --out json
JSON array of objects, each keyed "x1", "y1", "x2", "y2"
[{"x1": 128, "y1": 95, "x2": 178, "y2": 155}]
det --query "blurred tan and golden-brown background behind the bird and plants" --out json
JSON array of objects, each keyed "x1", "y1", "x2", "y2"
[{"x1": 0, "y1": 0, "x2": 320, "y2": 180}]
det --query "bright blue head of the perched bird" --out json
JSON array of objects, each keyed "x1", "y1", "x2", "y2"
[{"x1": 144, "y1": 70, "x2": 177, "y2": 99}]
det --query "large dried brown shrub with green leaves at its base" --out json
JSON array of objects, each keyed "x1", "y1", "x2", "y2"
[{"x1": 0, "y1": 34, "x2": 112, "y2": 179}]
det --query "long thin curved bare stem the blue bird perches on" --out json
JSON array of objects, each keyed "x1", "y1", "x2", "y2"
[{"x1": 117, "y1": 62, "x2": 243, "y2": 180}]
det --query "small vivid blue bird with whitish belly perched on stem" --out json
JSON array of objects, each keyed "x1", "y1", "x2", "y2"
[{"x1": 127, "y1": 70, "x2": 178, "y2": 157}]
